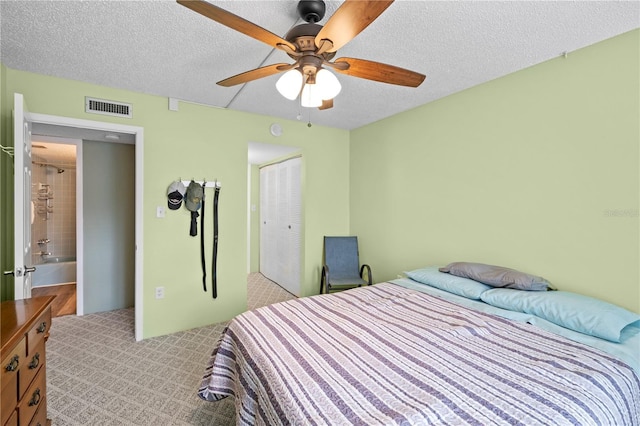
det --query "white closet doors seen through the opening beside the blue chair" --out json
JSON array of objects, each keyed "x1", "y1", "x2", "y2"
[{"x1": 260, "y1": 157, "x2": 302, "y2": 296}]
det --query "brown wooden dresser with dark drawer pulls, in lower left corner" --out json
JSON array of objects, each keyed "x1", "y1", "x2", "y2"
[{"x1": 0, "y1": 296, "x2": 55, "y2": 426}]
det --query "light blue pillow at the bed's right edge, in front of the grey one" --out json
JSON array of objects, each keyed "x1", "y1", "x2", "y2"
[{"x1": 480, "y1": 288, "x2": 640, "y2": 343}]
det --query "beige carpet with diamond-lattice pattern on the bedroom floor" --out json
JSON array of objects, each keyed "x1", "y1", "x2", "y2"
[{"x1": 47, "y1": 274, "x2": 294, "y2": 426}]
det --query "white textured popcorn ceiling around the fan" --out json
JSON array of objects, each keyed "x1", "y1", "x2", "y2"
[{"x1": 0, "y1": 0, "x2": 640, "y2": 129}]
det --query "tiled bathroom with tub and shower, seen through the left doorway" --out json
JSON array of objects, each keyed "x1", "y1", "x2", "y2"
[{"x1": 31, "y1": 140, "x2": 77, "y2": 316}]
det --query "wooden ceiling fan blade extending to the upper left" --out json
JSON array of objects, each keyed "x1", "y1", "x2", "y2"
[{"x1": 176, "y1": 0, "x2": 297, "y2": 51}]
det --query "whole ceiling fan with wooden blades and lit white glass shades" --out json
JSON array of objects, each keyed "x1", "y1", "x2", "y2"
[{"x1": 177, "y1": 0, "x2": 425, "y2": 109}]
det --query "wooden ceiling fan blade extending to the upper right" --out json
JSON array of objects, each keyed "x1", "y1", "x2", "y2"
[{"x1": 315, "y1": 0, "x2": 393, "y2": 52}]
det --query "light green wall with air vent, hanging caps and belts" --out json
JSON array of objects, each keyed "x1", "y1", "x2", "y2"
[{"x1": 0, "y1": 68, "x2": 349, "y2": 338}]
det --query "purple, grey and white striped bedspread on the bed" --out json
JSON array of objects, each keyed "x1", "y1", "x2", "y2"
[{"x1": 198, "y1": 283, "x2": 640, "y2": 425}]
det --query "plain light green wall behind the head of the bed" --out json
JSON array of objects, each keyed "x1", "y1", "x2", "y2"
[{"x1": 350, "y1": 31, "x2": 640, "y2": 312}]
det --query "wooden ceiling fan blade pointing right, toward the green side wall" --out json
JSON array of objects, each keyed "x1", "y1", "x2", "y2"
[{"x1": 333, "y1": 58, "x2": 425, "y2": 87}]
